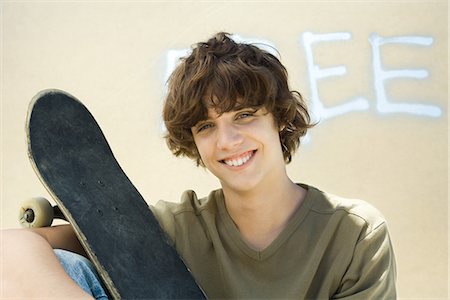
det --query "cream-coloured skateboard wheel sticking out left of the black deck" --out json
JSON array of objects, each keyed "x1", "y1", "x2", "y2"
[{"x1": 19, "y1": 197, "x2": 54, "y2": 228}]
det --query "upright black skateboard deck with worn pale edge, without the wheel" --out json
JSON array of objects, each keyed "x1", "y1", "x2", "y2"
[{"x1": 26, "y1": 90, "x2": 205, "y2": 299}]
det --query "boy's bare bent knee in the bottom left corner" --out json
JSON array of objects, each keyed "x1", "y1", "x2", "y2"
[{"x1": 0, "y1": 230, "x2": 92, "y2": 299}]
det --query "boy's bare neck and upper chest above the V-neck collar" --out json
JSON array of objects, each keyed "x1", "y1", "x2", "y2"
[{"x1": 224, "y1": 176, "x2": 306, "y2": 250}]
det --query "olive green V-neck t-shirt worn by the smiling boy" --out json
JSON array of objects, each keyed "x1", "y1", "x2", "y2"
[{"x1": 151, "y1": 185, "x2": 396, "y2": 299}]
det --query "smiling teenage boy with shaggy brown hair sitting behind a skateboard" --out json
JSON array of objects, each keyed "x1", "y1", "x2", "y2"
[{"x1": 0, "y1": 33, "x2": 396, "y2": 299}]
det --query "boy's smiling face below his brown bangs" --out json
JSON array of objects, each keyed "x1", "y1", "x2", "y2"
[{"x1": 191, "y1": 108, "x2": 285, "y2": 192}]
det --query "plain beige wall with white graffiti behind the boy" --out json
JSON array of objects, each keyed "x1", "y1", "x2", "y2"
[{"x1": 1, "y1": 0, "x2": 448, "y2": 299}]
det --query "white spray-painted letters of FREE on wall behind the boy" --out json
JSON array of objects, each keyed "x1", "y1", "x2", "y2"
[{"x1": 164, "y1": 32, "x2": 442, "y2": 121}]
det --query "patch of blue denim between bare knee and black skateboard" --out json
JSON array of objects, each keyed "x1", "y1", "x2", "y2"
[{"x1": 55, "y1": 249, "x2": 108, "y2": 300}]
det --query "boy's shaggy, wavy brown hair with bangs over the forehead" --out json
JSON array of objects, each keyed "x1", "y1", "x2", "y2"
[{"x1": 163, "y1": 32, "x2": 313, "y2": 166}]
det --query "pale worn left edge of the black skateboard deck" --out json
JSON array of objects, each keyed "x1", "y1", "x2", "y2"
[{"x1": 25, "y1": 89, "x2": 121, "y2": 299}]
